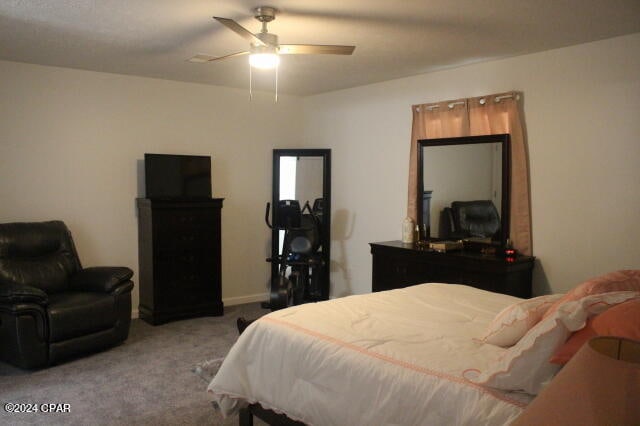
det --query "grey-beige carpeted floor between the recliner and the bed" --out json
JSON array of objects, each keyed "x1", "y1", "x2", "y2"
[{"x1": 0, "y1": 303, "x2": 268, "y2": 426}]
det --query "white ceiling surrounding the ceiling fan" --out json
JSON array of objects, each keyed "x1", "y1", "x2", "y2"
[{"x1": 0, "y1": 0, "x2": 640, "y2": 95}]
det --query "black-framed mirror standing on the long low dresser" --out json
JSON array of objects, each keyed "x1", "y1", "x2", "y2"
[{"x1": 417, "y1": 134, "x2": 510, "y2": 245}]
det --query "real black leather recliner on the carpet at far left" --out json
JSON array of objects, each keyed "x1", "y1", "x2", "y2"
[{"x1": 0, "y1": 221, "x2": 133, "y2": 369}]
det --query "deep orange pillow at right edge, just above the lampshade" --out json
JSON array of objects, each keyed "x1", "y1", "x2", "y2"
[{"x1": 549, "y1": 298, "x2": 640, "y2": 364}]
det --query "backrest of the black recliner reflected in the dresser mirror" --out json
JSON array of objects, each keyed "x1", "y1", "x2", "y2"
[{"x1": 451, "y1": 200, "x2": 500, "y2": 238}]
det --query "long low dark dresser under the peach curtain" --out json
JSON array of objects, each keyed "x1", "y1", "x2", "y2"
[{"x1": 369, "y1": 241, "x2": 535, "y2": 298}]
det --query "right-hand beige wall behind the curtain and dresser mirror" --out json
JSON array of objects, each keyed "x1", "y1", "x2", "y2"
[{"x1": 304, "y1": 34, "x2": 640, "y2": 296}]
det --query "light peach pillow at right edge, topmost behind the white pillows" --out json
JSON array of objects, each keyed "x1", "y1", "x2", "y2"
[{"x1": 543, "y1": 269, "x2": 640, "y2": 318}]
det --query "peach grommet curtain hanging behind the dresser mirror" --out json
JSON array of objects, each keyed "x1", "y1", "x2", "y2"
[{"x1": 407, "y1": 92, "x2": 532, "y2": 255}]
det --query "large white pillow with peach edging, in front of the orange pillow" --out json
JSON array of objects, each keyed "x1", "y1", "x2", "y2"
[{"x1": 464, "y1": 291, "x2": 640, "y2": 395}]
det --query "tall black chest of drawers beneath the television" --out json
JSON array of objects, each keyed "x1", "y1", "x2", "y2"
[{"x1": 137, "y1": 198, "x2": 223, "y2": 325}]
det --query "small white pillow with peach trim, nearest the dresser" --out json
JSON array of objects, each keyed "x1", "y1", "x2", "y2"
[{"x1": 480, "y1": 294, "x2": 563, "y2": 348}]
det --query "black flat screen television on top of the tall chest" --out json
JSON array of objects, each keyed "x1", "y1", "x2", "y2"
[{"x1": 144, "y1": 154, "x2": 211, "y2": 200}]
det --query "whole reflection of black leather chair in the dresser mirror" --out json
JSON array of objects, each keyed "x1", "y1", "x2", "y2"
[{"x1": 440, "y1": 200, "x2": 500, "y2": 240}]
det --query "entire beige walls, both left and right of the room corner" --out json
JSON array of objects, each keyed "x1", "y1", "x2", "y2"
[{"x1": 0, "y1": 34, "x2": 640, "y2": 306}]
